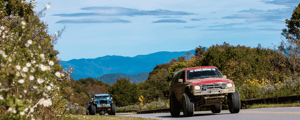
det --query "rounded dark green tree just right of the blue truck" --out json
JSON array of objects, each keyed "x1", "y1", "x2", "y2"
[{"x1": 108, "y1": 77, "x2": 140, "y2": 106}]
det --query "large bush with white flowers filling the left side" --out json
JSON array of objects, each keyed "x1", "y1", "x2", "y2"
[{"x1": 0, "y1": 0, "x2": 66, "y2": 119}]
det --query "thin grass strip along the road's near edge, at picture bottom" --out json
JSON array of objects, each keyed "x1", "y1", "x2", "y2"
[{"x1": 64, "y1": 114, "x2": 157, "y2": 120}]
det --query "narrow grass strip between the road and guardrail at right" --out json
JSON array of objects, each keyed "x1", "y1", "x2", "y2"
[{"x1": 248, "y1": 101, "x2": 300, "y2": 109}]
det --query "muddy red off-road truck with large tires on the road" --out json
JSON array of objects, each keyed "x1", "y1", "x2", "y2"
[{"x1": 169, "y1": 66, "x2": 241, "y2": 117}]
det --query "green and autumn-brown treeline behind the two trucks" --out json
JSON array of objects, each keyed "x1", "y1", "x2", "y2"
[{"x1": 65, "y1": 43, "x2": 294, "y2": 106}]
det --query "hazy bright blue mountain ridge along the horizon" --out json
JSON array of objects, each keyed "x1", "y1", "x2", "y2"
[{"x1": 60, "y1": 50, "x2": 195, "y2": 80}]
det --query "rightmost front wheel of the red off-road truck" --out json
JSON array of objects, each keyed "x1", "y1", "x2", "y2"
[{"x1": 228, "y1": 90, "x2": 241, "y2": 113}]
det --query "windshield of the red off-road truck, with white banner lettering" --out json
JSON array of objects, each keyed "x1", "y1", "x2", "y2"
[{"x1": 187, "y1": 68, "x2": 222, "y2": 80}]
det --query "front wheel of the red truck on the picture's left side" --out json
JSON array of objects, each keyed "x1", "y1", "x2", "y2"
[{"x1": 182, "y1": 93, "x2": 194, "y2": 116}]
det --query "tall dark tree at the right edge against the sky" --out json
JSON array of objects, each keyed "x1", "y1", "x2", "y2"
[{"x1": 279, "y1": 3, "x2": 300, "y2": 74}]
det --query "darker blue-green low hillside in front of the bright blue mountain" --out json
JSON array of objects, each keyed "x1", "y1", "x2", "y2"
[{"x1": 95, "y1": 72, "x2": 149, "y2": 84}]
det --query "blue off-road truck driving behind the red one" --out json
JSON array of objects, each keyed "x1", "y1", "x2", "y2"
[{"x1": 86, "y1": 93, "x2": 116, "y2": 115}]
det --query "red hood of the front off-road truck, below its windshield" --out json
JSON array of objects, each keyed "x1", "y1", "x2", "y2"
[{"x1": 189, "y1": 78, "x2": 233, "y2": 85}]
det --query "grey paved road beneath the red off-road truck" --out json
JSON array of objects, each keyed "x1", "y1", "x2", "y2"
[{"x1": 117, "y1": 107, "x2": 300, "y2": 120}]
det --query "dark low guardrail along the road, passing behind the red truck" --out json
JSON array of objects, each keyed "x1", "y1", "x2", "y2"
[{"x1": 137, "y1": 94, "x2": 300, "y2": 114}]
